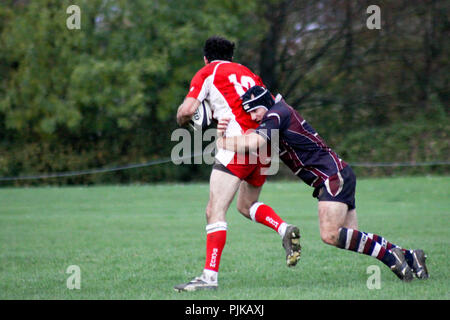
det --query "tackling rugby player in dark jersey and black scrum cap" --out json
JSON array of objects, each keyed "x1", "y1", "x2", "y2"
[{"x1": 217, "y1": 86, "x2": 428, "y2": 281}]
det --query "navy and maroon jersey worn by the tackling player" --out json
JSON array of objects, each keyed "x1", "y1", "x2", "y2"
[{"x1": 255, "y1": 97, "x2": 347, "y2": 188}]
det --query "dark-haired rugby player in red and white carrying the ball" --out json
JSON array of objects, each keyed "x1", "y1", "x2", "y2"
[{"x1": 174, "y1": 37, "x2": 301, "y2": 291}]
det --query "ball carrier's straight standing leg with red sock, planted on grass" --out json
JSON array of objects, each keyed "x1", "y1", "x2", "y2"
[{"x1": 174, "y1": 169, "x2": 240, "y2": 292}]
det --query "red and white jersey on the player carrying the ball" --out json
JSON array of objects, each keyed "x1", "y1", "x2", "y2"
[{"x1": 187, "y1": 60, "x2": 264, "y2": 165}]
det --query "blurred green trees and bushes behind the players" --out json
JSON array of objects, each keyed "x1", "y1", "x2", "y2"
[{"x1": 0, "y1": 0, "x2": 450, "y2": 184}]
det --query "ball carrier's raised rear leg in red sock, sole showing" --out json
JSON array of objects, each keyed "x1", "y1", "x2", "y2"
[{"x1": 237, "y1": 181, "x2": 301, "y2": 267}]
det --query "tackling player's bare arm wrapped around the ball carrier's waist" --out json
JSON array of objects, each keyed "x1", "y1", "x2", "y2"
[{"x1": 217, "y1": 119, "x2": 267, "y2": 153}]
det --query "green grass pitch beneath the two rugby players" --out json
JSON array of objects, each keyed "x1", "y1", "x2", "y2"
[{"x1": 0, "y1": 177, "x2": 450, "y2": 300}]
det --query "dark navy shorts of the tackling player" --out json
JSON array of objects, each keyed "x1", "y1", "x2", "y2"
[{"x1": 313, "y1": 166, "x2": 356, "y2": 210}]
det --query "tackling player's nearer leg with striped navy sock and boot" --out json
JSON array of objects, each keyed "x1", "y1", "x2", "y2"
[{"x1": 319, "y1": 201, "x2": 413, "y2": 281}]
